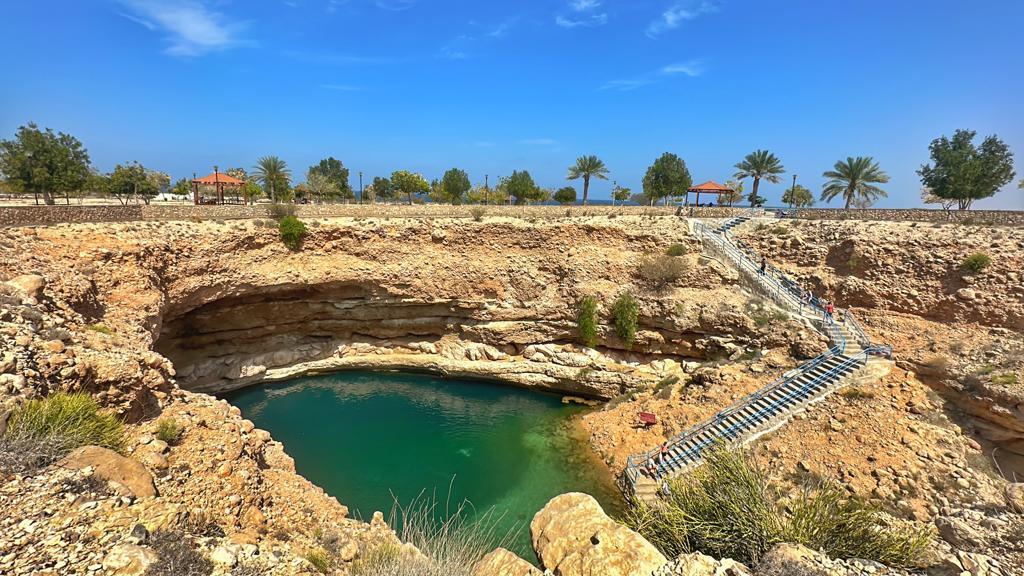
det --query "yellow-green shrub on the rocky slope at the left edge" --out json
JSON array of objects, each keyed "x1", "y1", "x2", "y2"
[{"x1": 0, "y1": 393, "x2": 125, "y2": 470}]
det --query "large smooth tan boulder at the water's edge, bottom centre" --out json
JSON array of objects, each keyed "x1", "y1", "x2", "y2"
[{"x1": 529, "y1": 492, "x2": 668, "y2": 576}]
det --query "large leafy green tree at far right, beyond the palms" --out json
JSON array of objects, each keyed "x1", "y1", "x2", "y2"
[{"x1": 918, "y1": 130, "x2": 1015, "y2": 210}]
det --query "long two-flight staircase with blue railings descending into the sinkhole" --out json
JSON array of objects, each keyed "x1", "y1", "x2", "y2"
[{"x1": 623, "y1": 217, "x2": 892, "y2": 500}]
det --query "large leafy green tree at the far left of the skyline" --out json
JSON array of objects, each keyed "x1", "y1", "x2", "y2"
[{"x1": 0, "y1": 122, "x2": 89, "y2": 204}]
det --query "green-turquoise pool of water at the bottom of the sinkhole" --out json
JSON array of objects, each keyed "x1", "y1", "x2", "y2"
[{"x1": 227, "y1": 372, "x2": 622, "y2": 559}]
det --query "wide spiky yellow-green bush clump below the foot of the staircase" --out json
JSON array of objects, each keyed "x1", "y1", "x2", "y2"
[{"x1": 624, "y1": 447, "x2": 931, "y2": 567}]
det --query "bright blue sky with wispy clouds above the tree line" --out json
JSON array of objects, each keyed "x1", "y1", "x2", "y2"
[{"x1": 0, "y1": 0, "x2": 1024, "y2": 209}]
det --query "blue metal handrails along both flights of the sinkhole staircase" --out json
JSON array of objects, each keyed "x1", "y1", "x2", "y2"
[{"x1": 625, "y1": 215, "x2": 892, "y2": 491}]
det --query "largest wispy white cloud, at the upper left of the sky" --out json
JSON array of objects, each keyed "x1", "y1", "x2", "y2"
[{"x1": 119, "y1": 0, "x2": 246, "y2": 56}]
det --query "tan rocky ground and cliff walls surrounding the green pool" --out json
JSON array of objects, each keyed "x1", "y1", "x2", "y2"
[{"x1": 0, "y1": 216, "x2": 1024, "y2": 576}]
